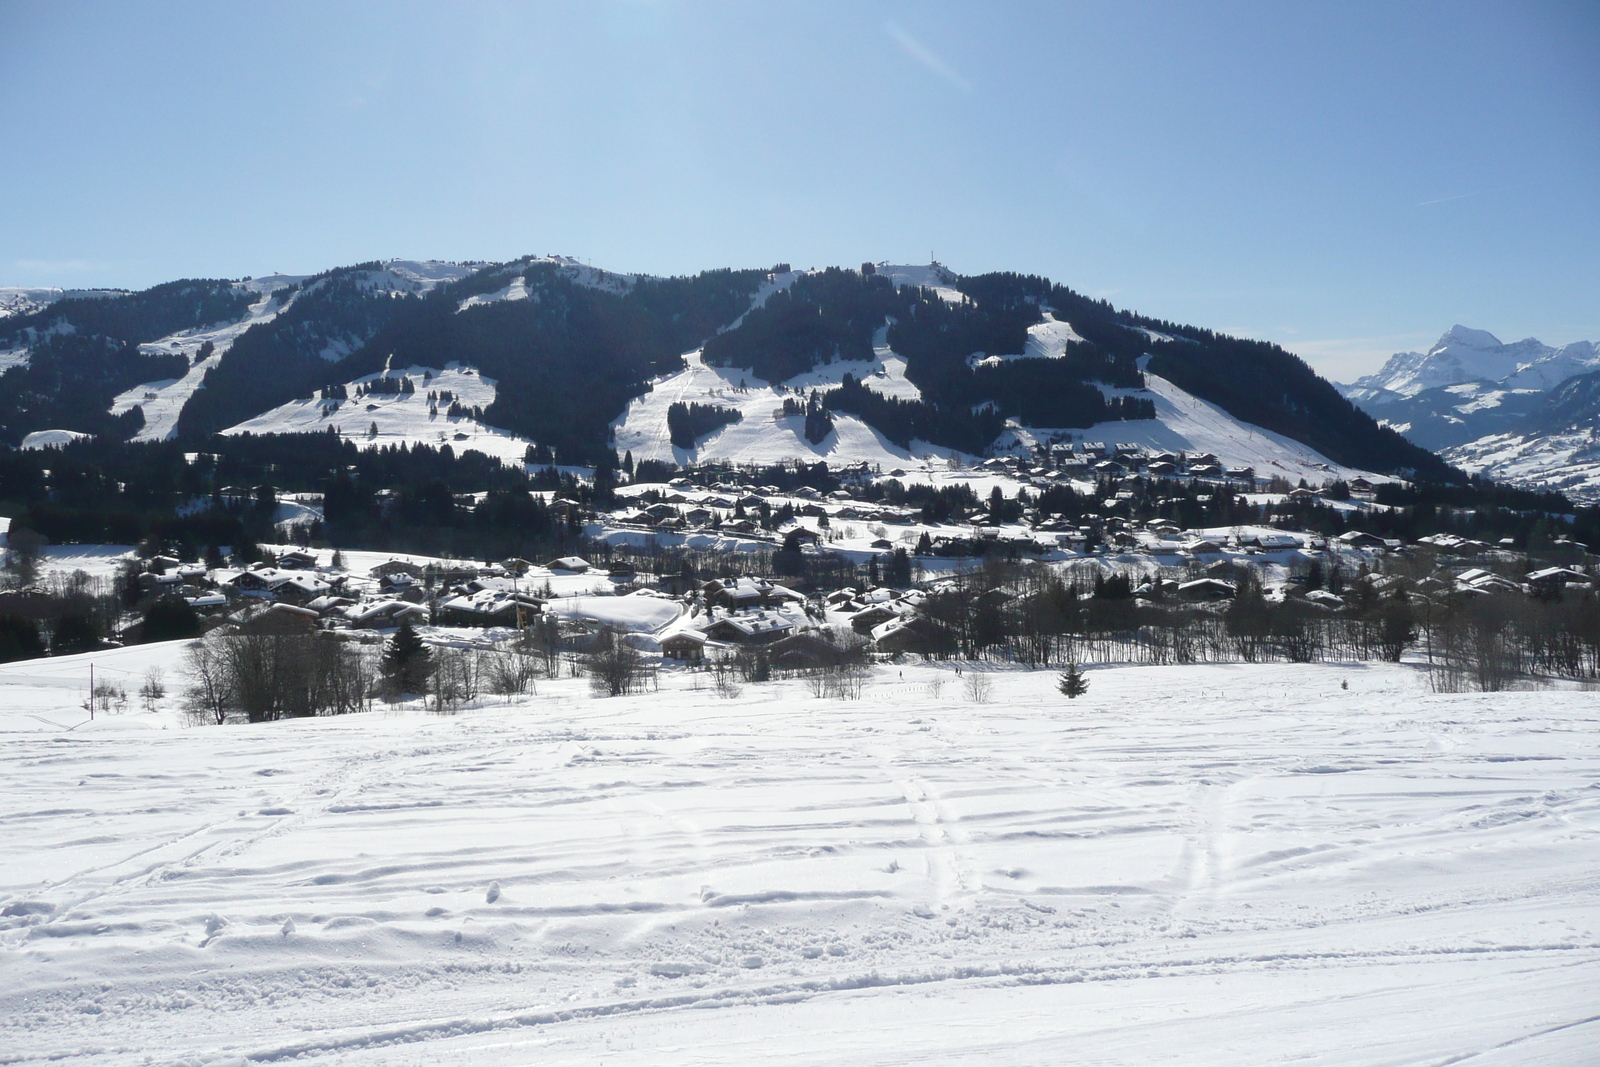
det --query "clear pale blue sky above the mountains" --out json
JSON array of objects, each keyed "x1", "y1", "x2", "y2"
[{"x1": 0, "y1": 0, "x2": 1600, "y2": 381}]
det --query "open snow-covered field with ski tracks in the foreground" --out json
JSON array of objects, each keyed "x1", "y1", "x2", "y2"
[{"x1": 0, "y1": 655, "x2": 1600, "y2": 1067}]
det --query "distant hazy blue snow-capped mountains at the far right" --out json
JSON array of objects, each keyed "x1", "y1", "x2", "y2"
[{"x1": 1339, "y1": 325, "x2": 1600, "y2": 502}]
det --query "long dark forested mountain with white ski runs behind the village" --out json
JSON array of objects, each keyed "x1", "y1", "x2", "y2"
[{"x1": 0, "y1": 256, "x2": 1453, "y2": 478}]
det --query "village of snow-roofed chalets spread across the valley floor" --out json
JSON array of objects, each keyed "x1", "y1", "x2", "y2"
[{"x1": 106, "y1": 443, "x2": 1595, "y2": 684}]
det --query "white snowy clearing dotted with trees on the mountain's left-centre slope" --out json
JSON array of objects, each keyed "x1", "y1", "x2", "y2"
[{"x1": 222, "y1": 362, "x2": 533, "y2": 467}]
